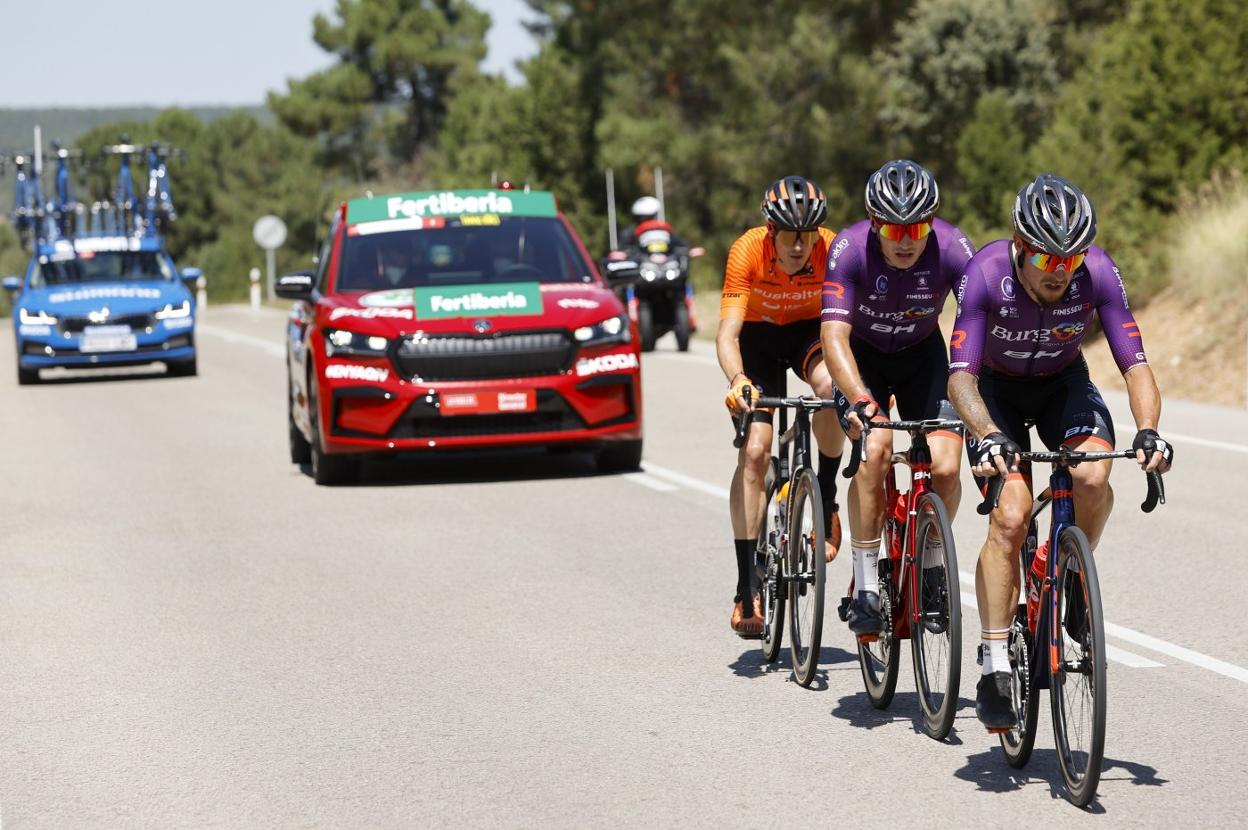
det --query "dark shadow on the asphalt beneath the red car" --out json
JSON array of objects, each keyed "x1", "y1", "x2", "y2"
[{"x1": 300, "y1": 448, "x2": 628, "y2": 487}]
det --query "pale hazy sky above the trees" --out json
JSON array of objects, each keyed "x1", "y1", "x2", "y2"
[{"x1": 0, "y1": 0, "x2": 537, "y2": 107}]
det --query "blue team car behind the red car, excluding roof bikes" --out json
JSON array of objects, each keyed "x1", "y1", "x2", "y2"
[{"x1": 4, "y1": 236, "x2": 200, "y2": 384}]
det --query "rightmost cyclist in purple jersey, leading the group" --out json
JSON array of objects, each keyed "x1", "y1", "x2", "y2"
[{"x1": 948, "y1": 175, "x2": 1173, "y2": 731}]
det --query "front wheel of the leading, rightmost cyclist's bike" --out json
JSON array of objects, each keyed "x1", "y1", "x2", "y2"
[{"x1": 1048, "y1": 527, "x2": 1107, "y2": 806}]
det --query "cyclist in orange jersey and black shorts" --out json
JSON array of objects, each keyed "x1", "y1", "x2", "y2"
[{"x1": 715, "y1": 176, "x2": 845, "y2": 637}]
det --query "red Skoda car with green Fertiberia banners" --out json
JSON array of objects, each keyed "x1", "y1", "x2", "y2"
[{"x1": 277, "y1": 190, "x2": 641, "y2": 483}]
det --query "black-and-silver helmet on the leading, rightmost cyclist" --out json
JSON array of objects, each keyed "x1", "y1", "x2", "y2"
[{"x1": 1013, "y1": 173, "x2": 1096, "y2": 257}]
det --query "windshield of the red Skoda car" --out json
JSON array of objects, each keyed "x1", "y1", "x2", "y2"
[{"x1": 336, "y1": 216, "x2": 593, "y2": 292}]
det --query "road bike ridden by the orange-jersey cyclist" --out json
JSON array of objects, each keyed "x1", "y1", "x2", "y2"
[{"x1": 733, "y1": 388, "x2": 836, "y2": 686}]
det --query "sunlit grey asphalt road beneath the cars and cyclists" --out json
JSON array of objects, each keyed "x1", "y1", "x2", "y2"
[{"x1": 0, "y1": 307, "x2": 1248, "y2": 828}]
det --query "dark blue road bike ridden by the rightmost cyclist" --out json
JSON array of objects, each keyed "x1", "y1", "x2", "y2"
[{"x1": 977, "y1": 447, "x2": 1166, "y2": 806}]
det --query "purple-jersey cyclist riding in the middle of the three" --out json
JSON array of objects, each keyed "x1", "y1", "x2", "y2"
[{"x1": 821, "y1": 159, "x2": 975, "y2": 637}]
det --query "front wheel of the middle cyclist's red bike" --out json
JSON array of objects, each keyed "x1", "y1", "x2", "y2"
[{"x1": 910, "y1": 493, "x2": 962, "y2": 740}]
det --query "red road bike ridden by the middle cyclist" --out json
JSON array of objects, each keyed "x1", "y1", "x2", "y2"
[{"x1": 837, "y1": 418, "x2": 962, "y2": 740}]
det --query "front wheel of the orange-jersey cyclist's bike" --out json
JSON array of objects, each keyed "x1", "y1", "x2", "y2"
[{"x1": 787, "y1": 467, "x2": 826, "y2": 686}]
